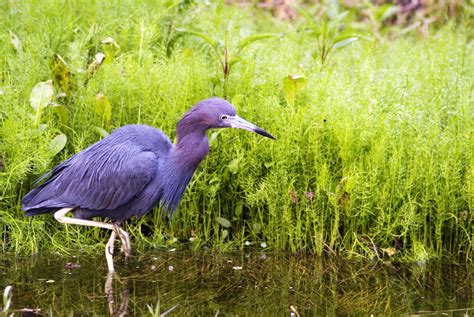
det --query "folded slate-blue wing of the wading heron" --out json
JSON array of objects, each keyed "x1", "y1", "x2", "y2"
[{"x1": 24, "y1": 142, "x2": 159, "y2": 210}]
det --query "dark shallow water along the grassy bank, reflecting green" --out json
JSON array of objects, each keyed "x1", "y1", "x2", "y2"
[{"x1": 0, "y1": 252, "x2": 474, "y2": 316}]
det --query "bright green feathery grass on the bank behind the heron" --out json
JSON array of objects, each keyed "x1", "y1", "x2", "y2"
[{"x1": 0, "y1": 0, "x2": 474, "y2": 261}]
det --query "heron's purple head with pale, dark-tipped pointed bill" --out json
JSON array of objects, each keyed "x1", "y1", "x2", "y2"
[{"x1": 183, "y1": 97, "x2": 275, "y2": 139}]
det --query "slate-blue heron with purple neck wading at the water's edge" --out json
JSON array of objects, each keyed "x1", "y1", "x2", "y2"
[{"x1": 21, "y1": 97, "x2": 275, "y2": 272}]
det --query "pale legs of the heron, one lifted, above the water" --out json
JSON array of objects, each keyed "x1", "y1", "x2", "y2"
[{"x1": 54, "y1": 208, "x2": 132, "y2": 272}]
